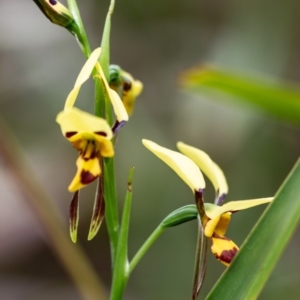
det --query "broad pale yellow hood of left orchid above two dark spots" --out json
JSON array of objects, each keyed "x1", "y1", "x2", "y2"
[{"x1": 56, "y1": 107, "x2": 113, "y2": 139}]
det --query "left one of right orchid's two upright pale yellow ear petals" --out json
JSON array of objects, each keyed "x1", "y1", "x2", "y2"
[{"x1": 142, "y1": 139, "x2": 205, "y2": 192}]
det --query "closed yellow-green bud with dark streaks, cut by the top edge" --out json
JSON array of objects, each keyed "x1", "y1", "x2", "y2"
[{"x1": 33, "y1": 0, "x2": 74, "y2": 27}]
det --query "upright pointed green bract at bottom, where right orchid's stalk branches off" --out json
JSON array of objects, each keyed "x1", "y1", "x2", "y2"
[{"x1": 110, "y1": 168, "x2": 134, "y2": 300}]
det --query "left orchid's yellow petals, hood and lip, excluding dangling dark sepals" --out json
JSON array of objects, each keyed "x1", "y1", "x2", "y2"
[{"x1": 56, "y1": 48, "x2": 128, "y2": 192}]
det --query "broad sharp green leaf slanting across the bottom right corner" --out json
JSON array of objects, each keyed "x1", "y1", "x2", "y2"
[{"x1": 206, "y1": 160, "x2": 300, "y2": 300}]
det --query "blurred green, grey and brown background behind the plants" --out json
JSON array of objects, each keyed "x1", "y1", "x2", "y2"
[{"x1": 0, "y1": 0, "x2": 300, "y2": 300}]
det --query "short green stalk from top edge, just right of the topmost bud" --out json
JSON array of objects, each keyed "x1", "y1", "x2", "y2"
[{"x1": 67, "y1": 0, "x2": 91, "y2": 58}]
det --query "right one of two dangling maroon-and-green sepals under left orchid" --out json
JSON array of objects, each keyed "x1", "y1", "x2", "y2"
[{"x1": 88, "y1": 175, "x2": 105, "y2": 241}]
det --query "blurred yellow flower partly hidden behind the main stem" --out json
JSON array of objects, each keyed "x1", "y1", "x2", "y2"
[{"x1": 109, "y1": 65, "x2": 143, "y2": 115}]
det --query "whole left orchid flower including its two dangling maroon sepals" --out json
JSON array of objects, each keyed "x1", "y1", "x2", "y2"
[{"x1": 56, "y1": 48, "x2": 128, "y2": 242}]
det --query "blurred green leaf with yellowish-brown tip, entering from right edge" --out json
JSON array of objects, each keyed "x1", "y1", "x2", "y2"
[{"x1": 181, "y1": 66, "x2": 300, "y2": 125}]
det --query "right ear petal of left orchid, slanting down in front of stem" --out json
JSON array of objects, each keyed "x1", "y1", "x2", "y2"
[{"x1": 96, "y1": 64, "x2": 128, "y2": 123}]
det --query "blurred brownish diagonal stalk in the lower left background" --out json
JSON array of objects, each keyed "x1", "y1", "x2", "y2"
[{"x1": 0, "y1": 119, "x2": 107, "y2": 300}]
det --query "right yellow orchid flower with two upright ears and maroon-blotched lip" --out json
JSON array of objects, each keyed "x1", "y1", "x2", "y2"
[{"x1": 142, "y1": 140, "x2": 273, "y2": 266}]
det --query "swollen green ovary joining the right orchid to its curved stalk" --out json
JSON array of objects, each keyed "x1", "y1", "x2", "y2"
[{"x1": 161, "y1": 204, "x2": 198, "y2": 228}]
